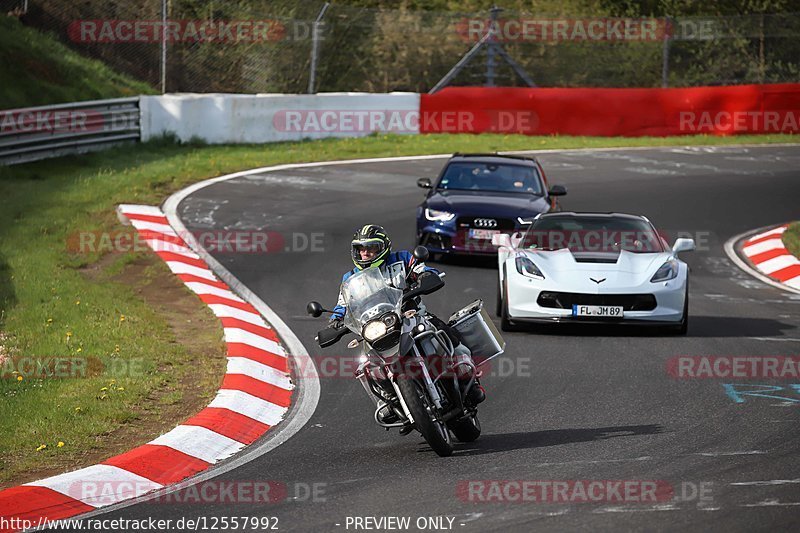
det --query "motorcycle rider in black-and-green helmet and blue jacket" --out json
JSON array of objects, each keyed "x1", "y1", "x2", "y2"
[{"x1": 330, "y1": 224, "x2": 486, "y2": 412}]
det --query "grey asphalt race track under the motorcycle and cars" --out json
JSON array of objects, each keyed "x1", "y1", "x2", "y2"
[{"x1": 78, "y1": 146, "x2": 800, "y2": 532}]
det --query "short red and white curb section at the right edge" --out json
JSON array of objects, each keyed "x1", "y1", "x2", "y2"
[{"x1": 742, "y1": 224, "x2": 800, "y2": 289}]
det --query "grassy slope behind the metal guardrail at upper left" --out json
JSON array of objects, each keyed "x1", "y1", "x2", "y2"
[{"x1": 0, "y1": 16, "x2": 155, "y2": 109}]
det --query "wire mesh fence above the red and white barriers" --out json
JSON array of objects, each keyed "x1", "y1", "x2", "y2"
[{"x1": 10, "y1": 0, "x2": 800, "y2": 93}]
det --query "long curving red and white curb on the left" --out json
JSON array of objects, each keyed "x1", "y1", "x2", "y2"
[{"x1": 0, "y1": 205, "x2": 294, "y2": 532}]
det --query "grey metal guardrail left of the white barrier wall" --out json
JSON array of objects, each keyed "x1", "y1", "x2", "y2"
[{"x1": 0, "y1": 96, "x2": 141, "y2": 165}]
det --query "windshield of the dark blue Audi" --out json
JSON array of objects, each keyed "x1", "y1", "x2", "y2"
[{"x1": 438, "y1": 162, "x2": 542, "y2": 196}]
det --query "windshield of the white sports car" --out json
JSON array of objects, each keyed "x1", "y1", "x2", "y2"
[{"x1": 520, "y1": 216, "x2": 664, "y2": 253}]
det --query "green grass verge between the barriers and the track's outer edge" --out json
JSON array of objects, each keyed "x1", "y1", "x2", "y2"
[{"x1": 0, "y1": 131, "x2": 794, "y2": 483}]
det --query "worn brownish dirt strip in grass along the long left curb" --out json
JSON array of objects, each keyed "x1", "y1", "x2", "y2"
[{"x1": 0, "y1": 253, "x2": 226, "y2": 488}]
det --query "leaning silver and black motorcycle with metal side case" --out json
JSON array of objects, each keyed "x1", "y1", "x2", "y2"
[{"x1": 306, "y1": 246, "x2": 505, "y2": 457}]
